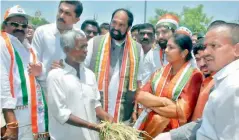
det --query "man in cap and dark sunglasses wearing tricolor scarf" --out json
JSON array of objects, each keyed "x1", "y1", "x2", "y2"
[{"x1": 0, "y1": 5, "x2": 48, "y2": 140}]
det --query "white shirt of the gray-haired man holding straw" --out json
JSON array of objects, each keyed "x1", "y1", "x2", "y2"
[{"x1": 47, "y1": 63, "x2": 101, "y2": 140}]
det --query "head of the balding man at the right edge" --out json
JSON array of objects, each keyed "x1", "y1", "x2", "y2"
[{"x1": 204, "y1": 23, "x2": 239, "y2": 71}]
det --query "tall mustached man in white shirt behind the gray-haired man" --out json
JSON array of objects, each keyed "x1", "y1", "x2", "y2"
[{"x1": 32, "y1": 0, "x2": 83, "y2": 93}]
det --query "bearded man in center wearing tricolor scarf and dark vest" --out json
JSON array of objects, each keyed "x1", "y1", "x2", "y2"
[{"x1": 85, "y1": 9, "x2": 144, "y2": 124}]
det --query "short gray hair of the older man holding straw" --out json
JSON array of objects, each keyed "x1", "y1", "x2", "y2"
[{"x1": 60, "y1": 30, "x2": 86, "y2": 50}]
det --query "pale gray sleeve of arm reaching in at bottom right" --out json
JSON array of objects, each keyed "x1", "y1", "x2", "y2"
[{"x1": 170, "y1": 120, "x2": 202, "y2": 140}]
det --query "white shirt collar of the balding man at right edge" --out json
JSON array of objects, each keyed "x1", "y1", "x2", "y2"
[{"x1": 213, "y1": 59, "x2": 239, "y2": 81}]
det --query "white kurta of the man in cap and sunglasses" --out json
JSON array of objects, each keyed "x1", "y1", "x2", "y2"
[{"x1": 0, "y1": 34, "x2": 31, "y2": 127}]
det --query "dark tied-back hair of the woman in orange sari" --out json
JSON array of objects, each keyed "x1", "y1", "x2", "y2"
[{"x1": 173, "y1": 34, "x2": 193, "y2": 61}]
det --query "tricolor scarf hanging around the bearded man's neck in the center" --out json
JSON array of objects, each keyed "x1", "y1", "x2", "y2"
[{"x1": 94, "y1": 33, "x2": 139, "y2": 121}]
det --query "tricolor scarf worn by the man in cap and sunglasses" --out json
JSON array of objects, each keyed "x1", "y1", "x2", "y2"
[{"x1": 1, "y1": 32, "x2": 48, "y2": 138}]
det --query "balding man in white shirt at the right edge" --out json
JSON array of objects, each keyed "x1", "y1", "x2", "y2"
[{"x1": 155, "y1": 23, "x2": 239, "y2": 140}]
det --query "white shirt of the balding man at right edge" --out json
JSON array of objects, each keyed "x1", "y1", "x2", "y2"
[{"x1": 197, "y1": 60, "x2": 239, "y2": 140}]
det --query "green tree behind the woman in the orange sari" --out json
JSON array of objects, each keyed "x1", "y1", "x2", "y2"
[{"x1": 149, "y1": 5, "x2": 213, "y2": 33}]
